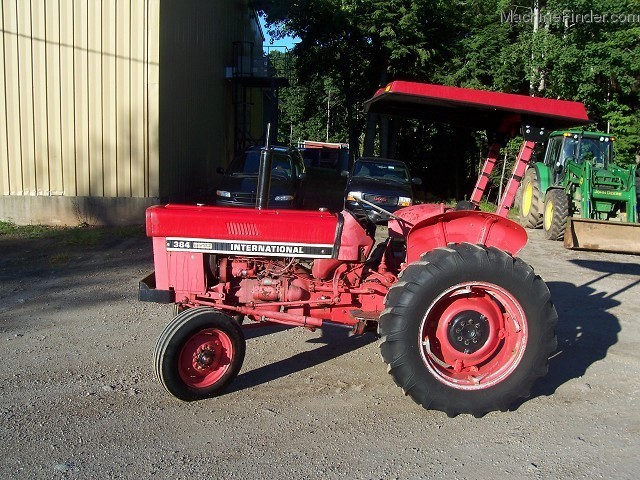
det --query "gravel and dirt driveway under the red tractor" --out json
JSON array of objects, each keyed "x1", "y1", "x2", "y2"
[{"x1": 0, "y1": 223, "x2": 640, "y2": 480}]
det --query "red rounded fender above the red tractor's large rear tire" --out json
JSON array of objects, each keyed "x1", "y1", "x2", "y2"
[{"x1": 407, "y1": 210, "x2": 527, "y2": 263}]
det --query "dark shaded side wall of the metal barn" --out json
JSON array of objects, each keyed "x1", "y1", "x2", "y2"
[{"x1": 159, "y1": 0, "x2": 263, "y2": 202}]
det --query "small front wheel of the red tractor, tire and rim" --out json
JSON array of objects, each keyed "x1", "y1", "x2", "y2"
[{"x1": 153, "y1": 307, "x2": 246, "y2": 401}]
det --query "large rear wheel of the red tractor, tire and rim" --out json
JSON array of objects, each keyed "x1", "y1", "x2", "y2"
[{"x1": 378, "y1": 243, "x2": 558, "y2": 417}]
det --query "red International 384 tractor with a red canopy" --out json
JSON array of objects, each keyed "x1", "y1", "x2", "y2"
[{"x1": 139, "y1": 82, "x2": 588, "y2": 416}]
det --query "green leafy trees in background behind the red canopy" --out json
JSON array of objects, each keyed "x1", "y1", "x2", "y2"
[{"x1": 255, "y1": 0, "x2": 640, "y2": 194}]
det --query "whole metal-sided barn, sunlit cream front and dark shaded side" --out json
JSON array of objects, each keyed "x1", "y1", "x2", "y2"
[{"x1": 0, "y1": 0, "x2": 262, "y2": 224}]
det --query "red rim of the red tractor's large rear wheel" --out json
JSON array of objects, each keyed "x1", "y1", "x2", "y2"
[{"x1": 419, "y1": 282, "x2": 528, "y2": 390}]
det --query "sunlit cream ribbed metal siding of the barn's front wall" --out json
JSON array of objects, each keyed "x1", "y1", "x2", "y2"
[{"x1": 0, "y1": 0, "x2": 160, "y2": 207}]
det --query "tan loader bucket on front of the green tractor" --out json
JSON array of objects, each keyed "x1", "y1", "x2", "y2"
[{"x1": 564, "y1": 218, "x2": 640, "y2": 255}]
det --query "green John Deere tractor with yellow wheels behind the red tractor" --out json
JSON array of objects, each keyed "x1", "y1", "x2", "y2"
[{"x1": 520, "y1": 130, "x2": 640, "y2": 250}]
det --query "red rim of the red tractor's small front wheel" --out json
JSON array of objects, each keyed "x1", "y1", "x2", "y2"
[{"x1": 178, "y1": 328, "x2": 234, "y2": 388}]
